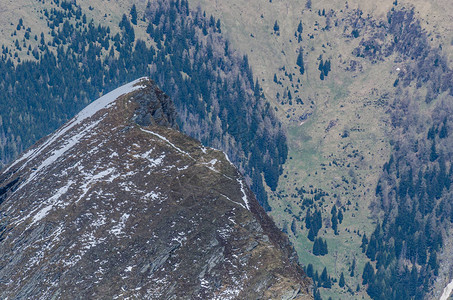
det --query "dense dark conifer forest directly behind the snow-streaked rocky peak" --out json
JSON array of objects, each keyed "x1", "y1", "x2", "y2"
[{"x1": 0, "y1": 0, "x2": 287, "y2": 209}]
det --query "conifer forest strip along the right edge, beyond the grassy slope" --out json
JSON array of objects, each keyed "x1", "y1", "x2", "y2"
[{"x1": 356, "y1": 10, "x2": 453, "y2": 299}]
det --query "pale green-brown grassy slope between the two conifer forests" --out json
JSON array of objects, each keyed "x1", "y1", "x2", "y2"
[{"x1": 188, "y1": 0, "x2": 453, "y2": 299}]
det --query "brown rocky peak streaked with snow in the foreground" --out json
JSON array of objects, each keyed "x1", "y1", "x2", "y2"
[{"x1": 0, "y1": 79, "x2": 311, "y2": 299}]
